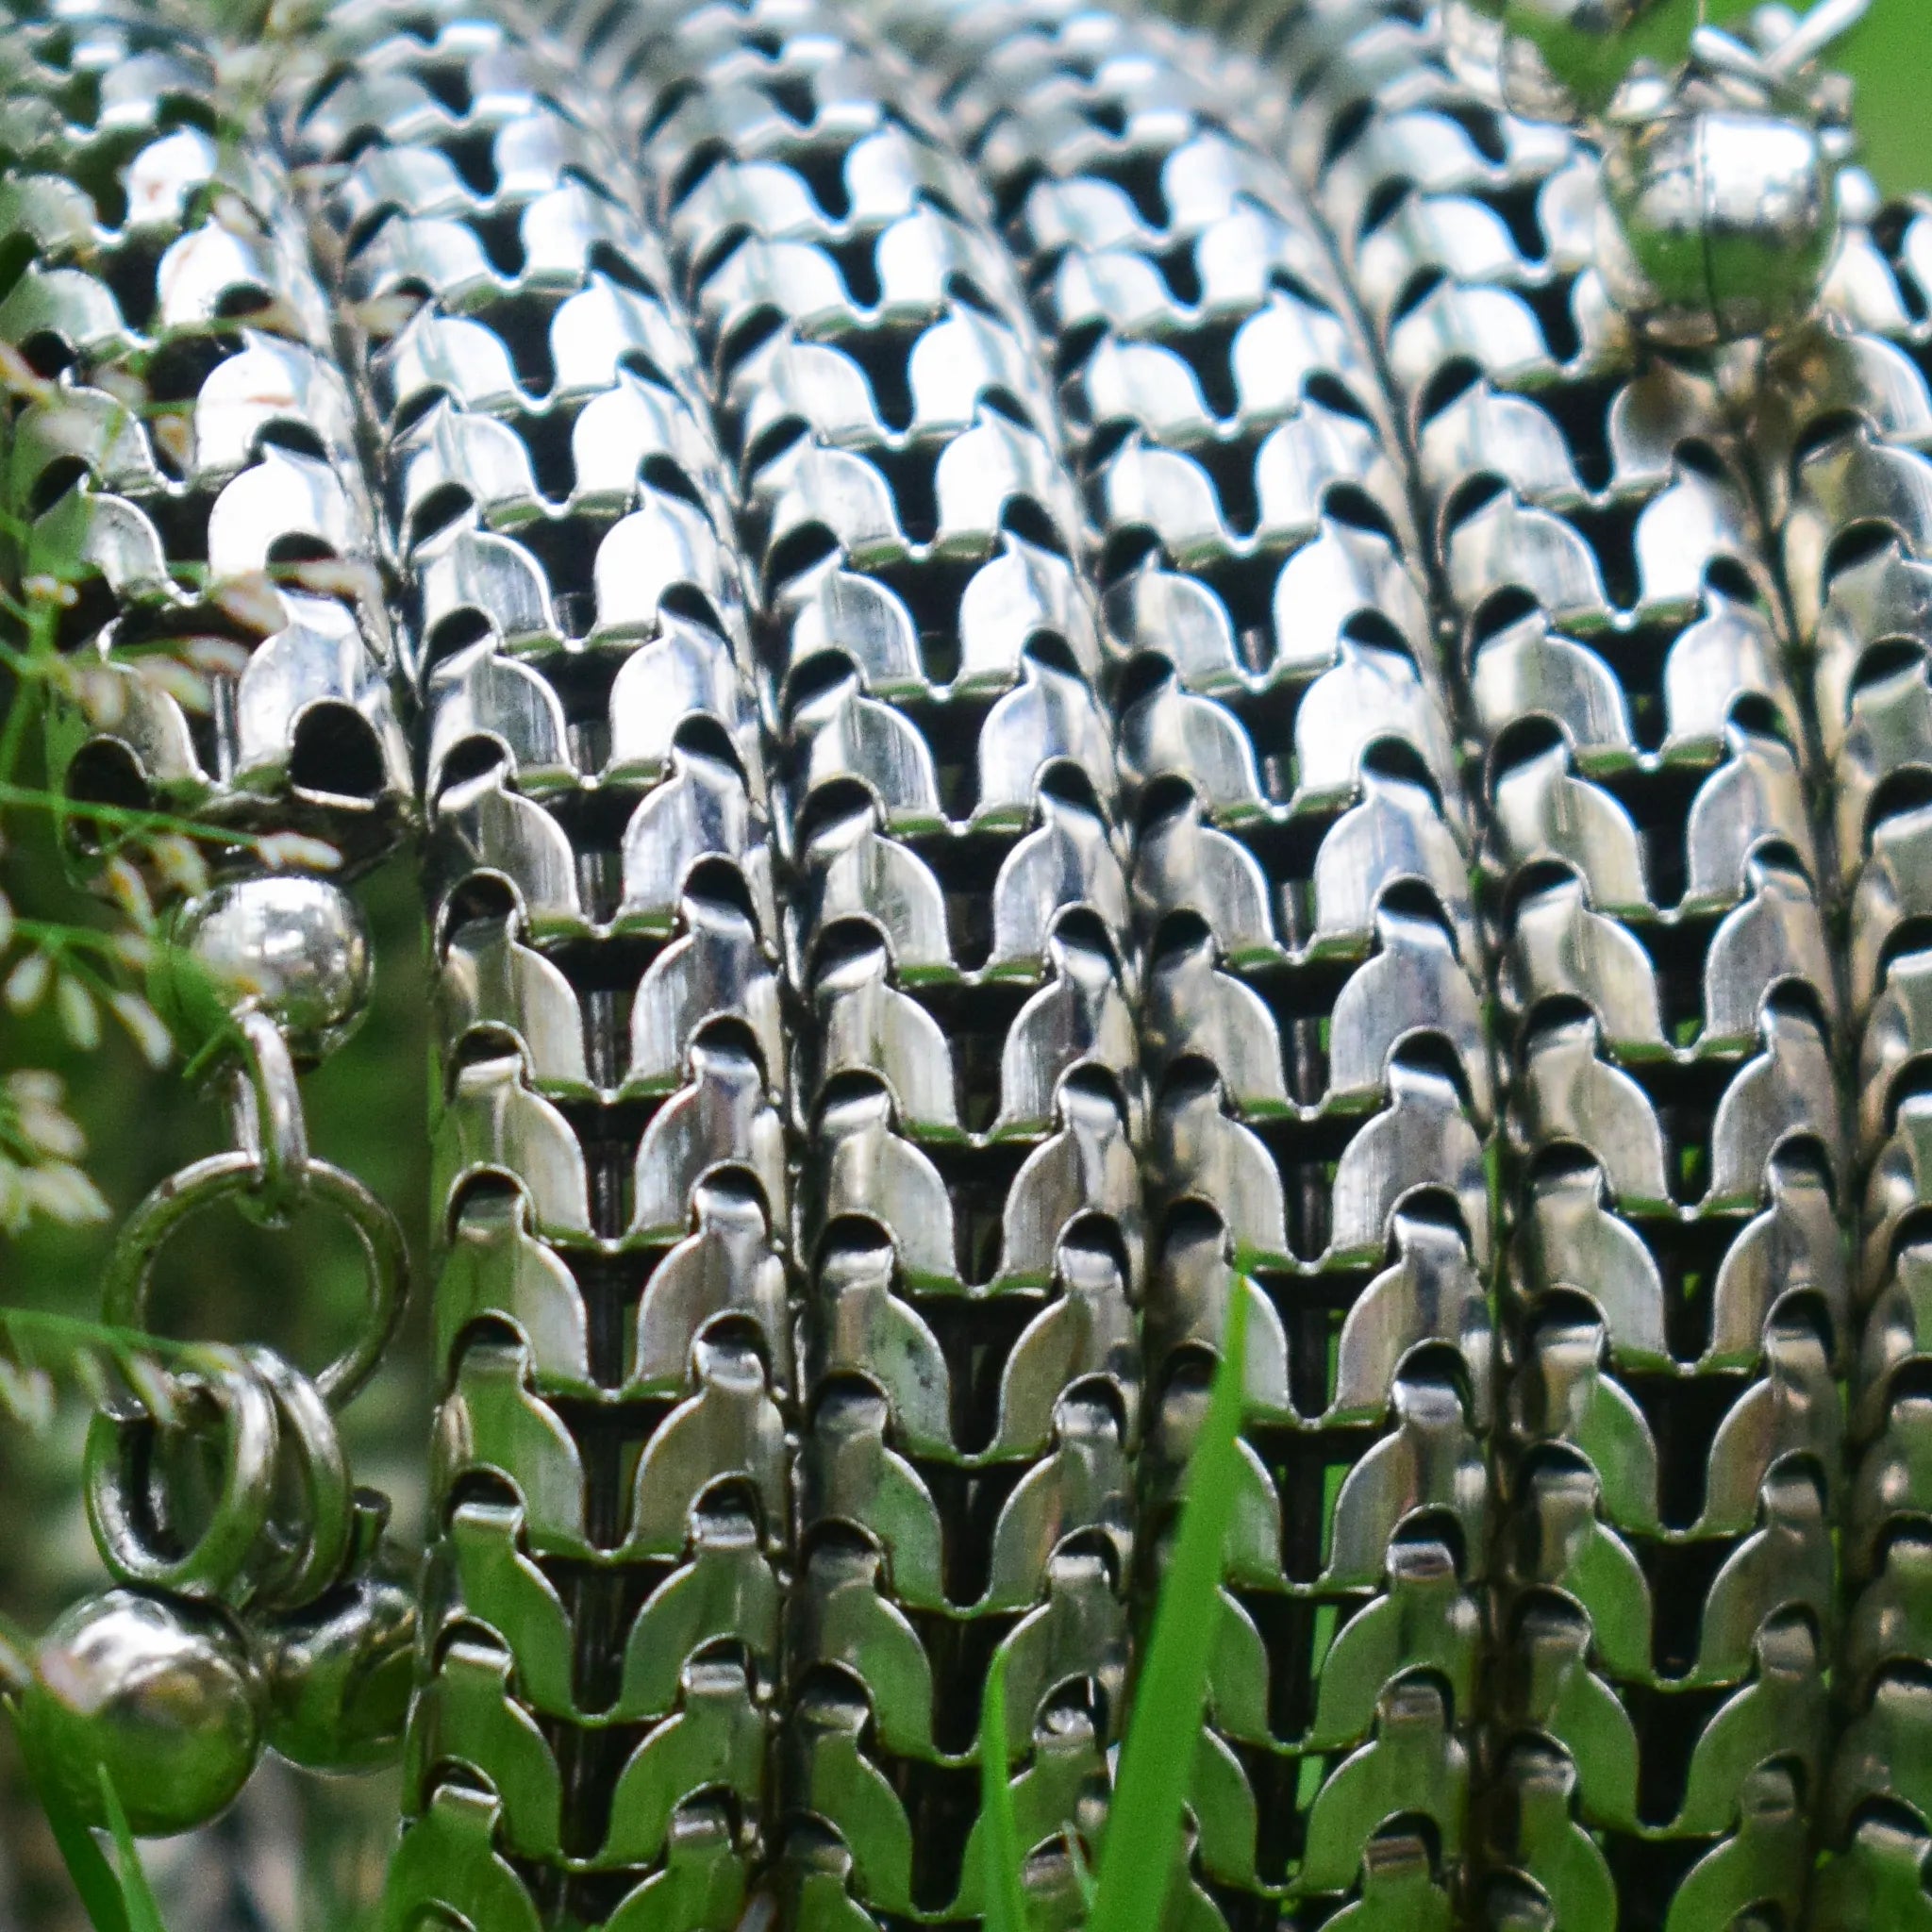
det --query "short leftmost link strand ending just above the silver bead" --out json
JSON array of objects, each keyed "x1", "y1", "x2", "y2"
[{"x1": 0, "y1": 0, "x2": 411, "y2": 900}]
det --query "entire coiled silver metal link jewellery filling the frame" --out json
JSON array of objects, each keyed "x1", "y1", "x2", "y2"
[{"x1": 0, "y1": 0, "x2": 1932, "y2": 1932}]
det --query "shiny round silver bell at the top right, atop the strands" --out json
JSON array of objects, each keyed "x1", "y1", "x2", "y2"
[{"x1": 1598, "y1": 108, "x2": 1840, "y2": 348}]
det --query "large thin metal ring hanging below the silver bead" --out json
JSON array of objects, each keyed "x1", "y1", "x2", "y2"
[{"x1": 100, "y1": 1148, "x2": 408, "y2": 1408}]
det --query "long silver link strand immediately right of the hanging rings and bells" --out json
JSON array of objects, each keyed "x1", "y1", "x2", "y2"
[{"x1": 279, "y1": 0, "x2": 798, "y2": 1932}]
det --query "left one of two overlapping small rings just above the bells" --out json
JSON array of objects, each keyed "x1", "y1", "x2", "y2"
[{"x1": 85, "y1": 1349, "x2": 280, "y2": 1598}]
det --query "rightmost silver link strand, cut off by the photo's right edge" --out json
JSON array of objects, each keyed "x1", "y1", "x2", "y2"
[{"x1": 1755, "y1": 179, "x2": 1932, "y2": 1932}]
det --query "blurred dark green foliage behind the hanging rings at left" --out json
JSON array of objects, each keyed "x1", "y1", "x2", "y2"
[{"x1": 0, "y1": 745, "x2": 429, "y2": 1932}]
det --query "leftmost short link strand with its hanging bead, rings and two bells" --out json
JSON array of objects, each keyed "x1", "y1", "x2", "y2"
[{"x1": 0, "y1": 0, "x2": 413, "y2": 1836}]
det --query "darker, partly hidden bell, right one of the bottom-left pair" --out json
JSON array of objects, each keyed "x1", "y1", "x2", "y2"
[{"x1": 255, "y1": 1490, "x2": 415, "y2": 1772}]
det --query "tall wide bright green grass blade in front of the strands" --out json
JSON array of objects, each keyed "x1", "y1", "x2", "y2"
[{"x1": 1088, "y1": 1277, "x2": 1248, "y2": 1932}]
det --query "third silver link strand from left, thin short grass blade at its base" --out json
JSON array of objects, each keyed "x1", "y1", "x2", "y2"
[{"x1": 509, "y1": 0, "x2": 1145, "y2": 1932}]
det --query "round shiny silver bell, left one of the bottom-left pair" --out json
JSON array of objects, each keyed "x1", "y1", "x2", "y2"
[{"x1": 19, "y1": 1591, "x2": 263, "y2": 1838}]
